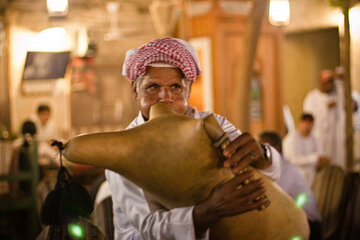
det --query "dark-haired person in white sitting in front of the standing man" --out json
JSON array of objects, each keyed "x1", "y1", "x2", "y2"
[{"x1": 283, "y1": 113, "x2": 330, "y2": 187}]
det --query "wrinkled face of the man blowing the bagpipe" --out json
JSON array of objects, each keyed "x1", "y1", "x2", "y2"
[{"x1": 132, "y1": 67, "x2": 190, "y2": 119}]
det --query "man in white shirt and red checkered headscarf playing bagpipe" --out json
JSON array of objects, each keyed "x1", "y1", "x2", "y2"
[{"x1": 105, "y1": 38, "x2": 281, "y2": 240}]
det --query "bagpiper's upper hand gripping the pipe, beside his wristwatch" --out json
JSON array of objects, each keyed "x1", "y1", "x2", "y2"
[{"x1": 223, "y1": 133, "x2": 272, "y2": 174}]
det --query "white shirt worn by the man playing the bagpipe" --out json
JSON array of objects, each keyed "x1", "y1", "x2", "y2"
[{"x1": 105, "y1": 107, "x2": 281, "y2": 240}]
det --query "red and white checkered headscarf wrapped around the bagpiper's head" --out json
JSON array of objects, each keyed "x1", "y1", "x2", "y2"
[{"x1": 122, "y1": 38, "x2": 201, "y2": 81}]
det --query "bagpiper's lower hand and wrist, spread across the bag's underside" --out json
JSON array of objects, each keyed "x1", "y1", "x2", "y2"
[{"x1": 193, "y1": 171, "x2": 269, "y2": 237}]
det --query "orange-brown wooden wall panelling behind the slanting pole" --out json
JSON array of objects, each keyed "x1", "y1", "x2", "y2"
[{"x1": 189, "y1": 2, "x2": 284, "y2": 135}]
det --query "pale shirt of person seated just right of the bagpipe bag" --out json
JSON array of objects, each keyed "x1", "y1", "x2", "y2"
[{"x1": 276, "y1": 159, "x2": 321, "y2": 221}]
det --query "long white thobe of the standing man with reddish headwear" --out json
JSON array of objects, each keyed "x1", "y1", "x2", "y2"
[{"x1": 304, "y1": 80, "x2": 346, "y2": 168}]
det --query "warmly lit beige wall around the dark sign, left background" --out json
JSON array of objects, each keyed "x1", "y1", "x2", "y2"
[{"x1": 6, "y1": 4, "x2": 157, "y2": 137}]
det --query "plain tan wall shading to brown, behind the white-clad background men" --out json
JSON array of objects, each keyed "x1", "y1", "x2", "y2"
[{"x1": 283, "y1": 28, "x2": 340, "y2": 127}]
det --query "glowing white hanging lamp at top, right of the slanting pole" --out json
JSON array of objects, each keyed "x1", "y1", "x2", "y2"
[{"x1": 269, "y1": 0, "x2": 290, "y2": 26}]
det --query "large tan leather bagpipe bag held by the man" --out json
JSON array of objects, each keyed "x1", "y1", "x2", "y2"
[{"x1": 63, "y1": 103, "x2": 309, "y2": 240}]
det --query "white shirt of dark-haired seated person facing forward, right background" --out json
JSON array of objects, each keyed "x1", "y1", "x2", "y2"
[{"x1": 283, "y1": 130, "x2": 319, "y2": 186}]
